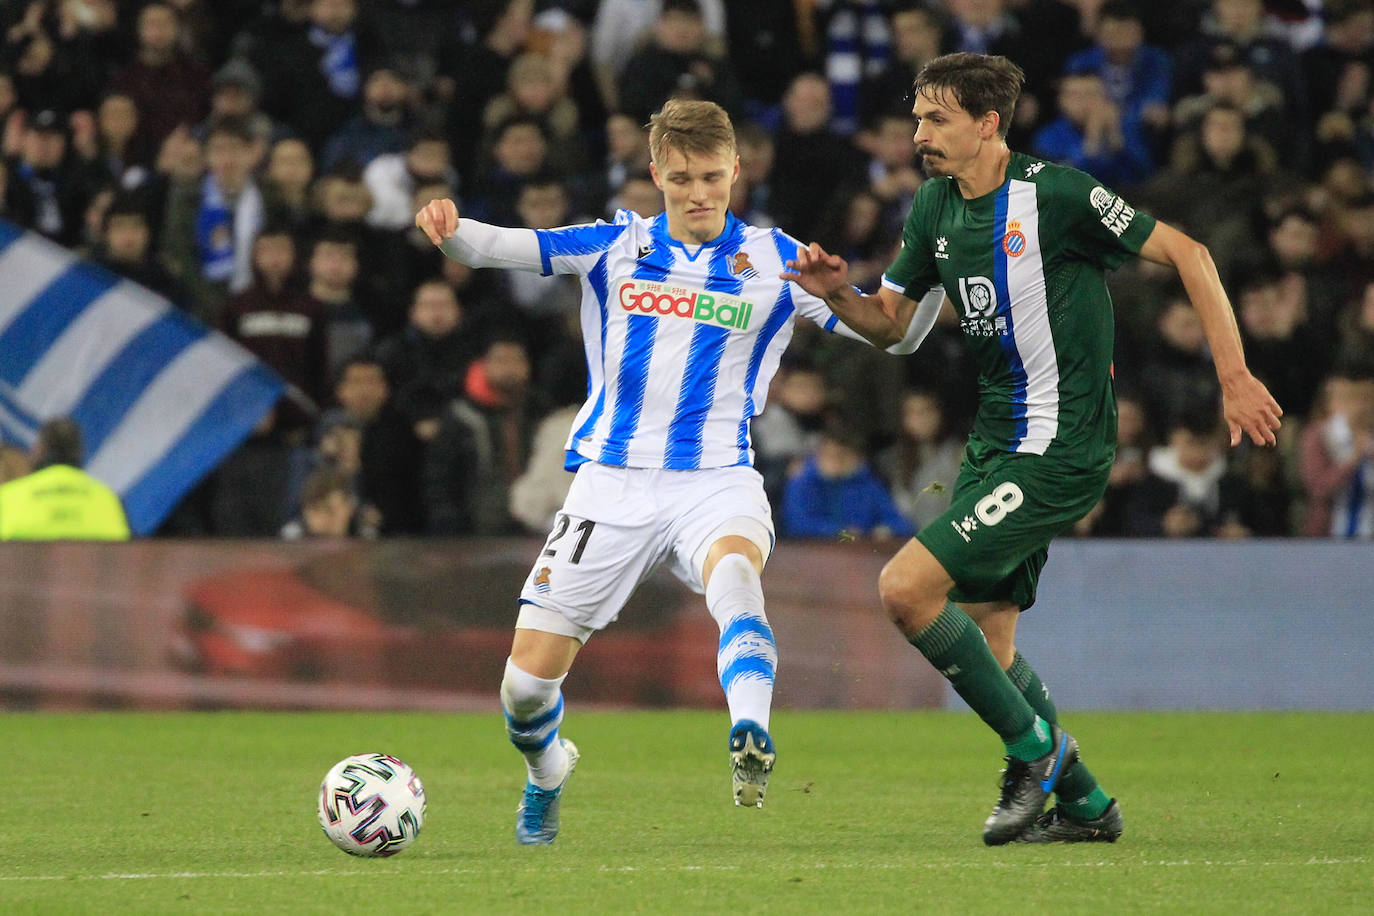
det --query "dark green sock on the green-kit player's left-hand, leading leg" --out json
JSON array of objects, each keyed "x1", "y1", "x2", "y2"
[{"x1": 907, "y1": 602, "x2": 1050, "y2": 759}]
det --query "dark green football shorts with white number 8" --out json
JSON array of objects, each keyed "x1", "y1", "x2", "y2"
[{"x1": 916, "y1": 441, "x2": 1112, "y2": 610}]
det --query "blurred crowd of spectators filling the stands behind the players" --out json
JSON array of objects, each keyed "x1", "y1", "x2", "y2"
[{"x1": 0, "y1": 0, "x2": 1374, "y2": 538}]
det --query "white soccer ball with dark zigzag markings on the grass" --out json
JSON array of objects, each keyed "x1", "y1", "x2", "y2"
[{"x1": 319, "y1": 754, "x2": 425, "y2": 856}]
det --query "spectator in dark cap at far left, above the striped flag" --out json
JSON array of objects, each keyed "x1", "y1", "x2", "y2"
[{"x1": 5, "y1": 111, "x2": 96, "y2": 246}]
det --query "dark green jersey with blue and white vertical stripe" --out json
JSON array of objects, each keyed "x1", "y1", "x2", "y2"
[{"x1": 882, "y1": 152, "x2": 1154, "y2": 467}]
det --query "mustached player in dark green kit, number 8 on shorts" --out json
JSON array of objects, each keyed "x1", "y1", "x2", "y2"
[{"x1": 783, "y1": 54, "x2": 1282, "y2": 846}]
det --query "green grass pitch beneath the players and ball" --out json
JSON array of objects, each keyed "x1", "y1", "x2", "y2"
[{"x1": 0, "y1": 709, "x2": 1374, "y2": 915}]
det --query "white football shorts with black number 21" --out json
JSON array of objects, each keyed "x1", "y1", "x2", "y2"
[{"x1": 515, "y1": 461, "x2": 774, "y2": 643}]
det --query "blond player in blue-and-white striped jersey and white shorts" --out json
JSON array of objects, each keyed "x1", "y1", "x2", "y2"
[{"x1": 416, "y1": 100, "x2": 944, "y2": 843}]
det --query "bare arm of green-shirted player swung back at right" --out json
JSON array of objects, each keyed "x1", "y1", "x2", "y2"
[{"x1": 1140, "y1": 222, "x2": 1283, "y2": 445}]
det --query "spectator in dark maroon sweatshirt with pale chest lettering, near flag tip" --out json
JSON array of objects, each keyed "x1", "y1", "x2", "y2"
[{"x1": 221, "y1": 225, "x2": 330, "y2": 414}]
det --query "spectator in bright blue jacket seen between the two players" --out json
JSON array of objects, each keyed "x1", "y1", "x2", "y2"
[{"x1": 782, "y1": 424, "x2": 916, "y2": 541}]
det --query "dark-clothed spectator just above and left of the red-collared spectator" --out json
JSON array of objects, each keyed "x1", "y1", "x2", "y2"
[{"x1": 376, "y1": 280, "x2": 477, "y2": 442}]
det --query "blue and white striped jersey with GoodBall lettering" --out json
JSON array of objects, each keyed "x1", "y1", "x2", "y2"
[{"x1": 536, "y1": 210, "x2": 857, "y2": 470}]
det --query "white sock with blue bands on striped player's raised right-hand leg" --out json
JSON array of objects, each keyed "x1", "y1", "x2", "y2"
[{"x1": 706, "y1": 553, "x2": 778, "y2": 731}]
